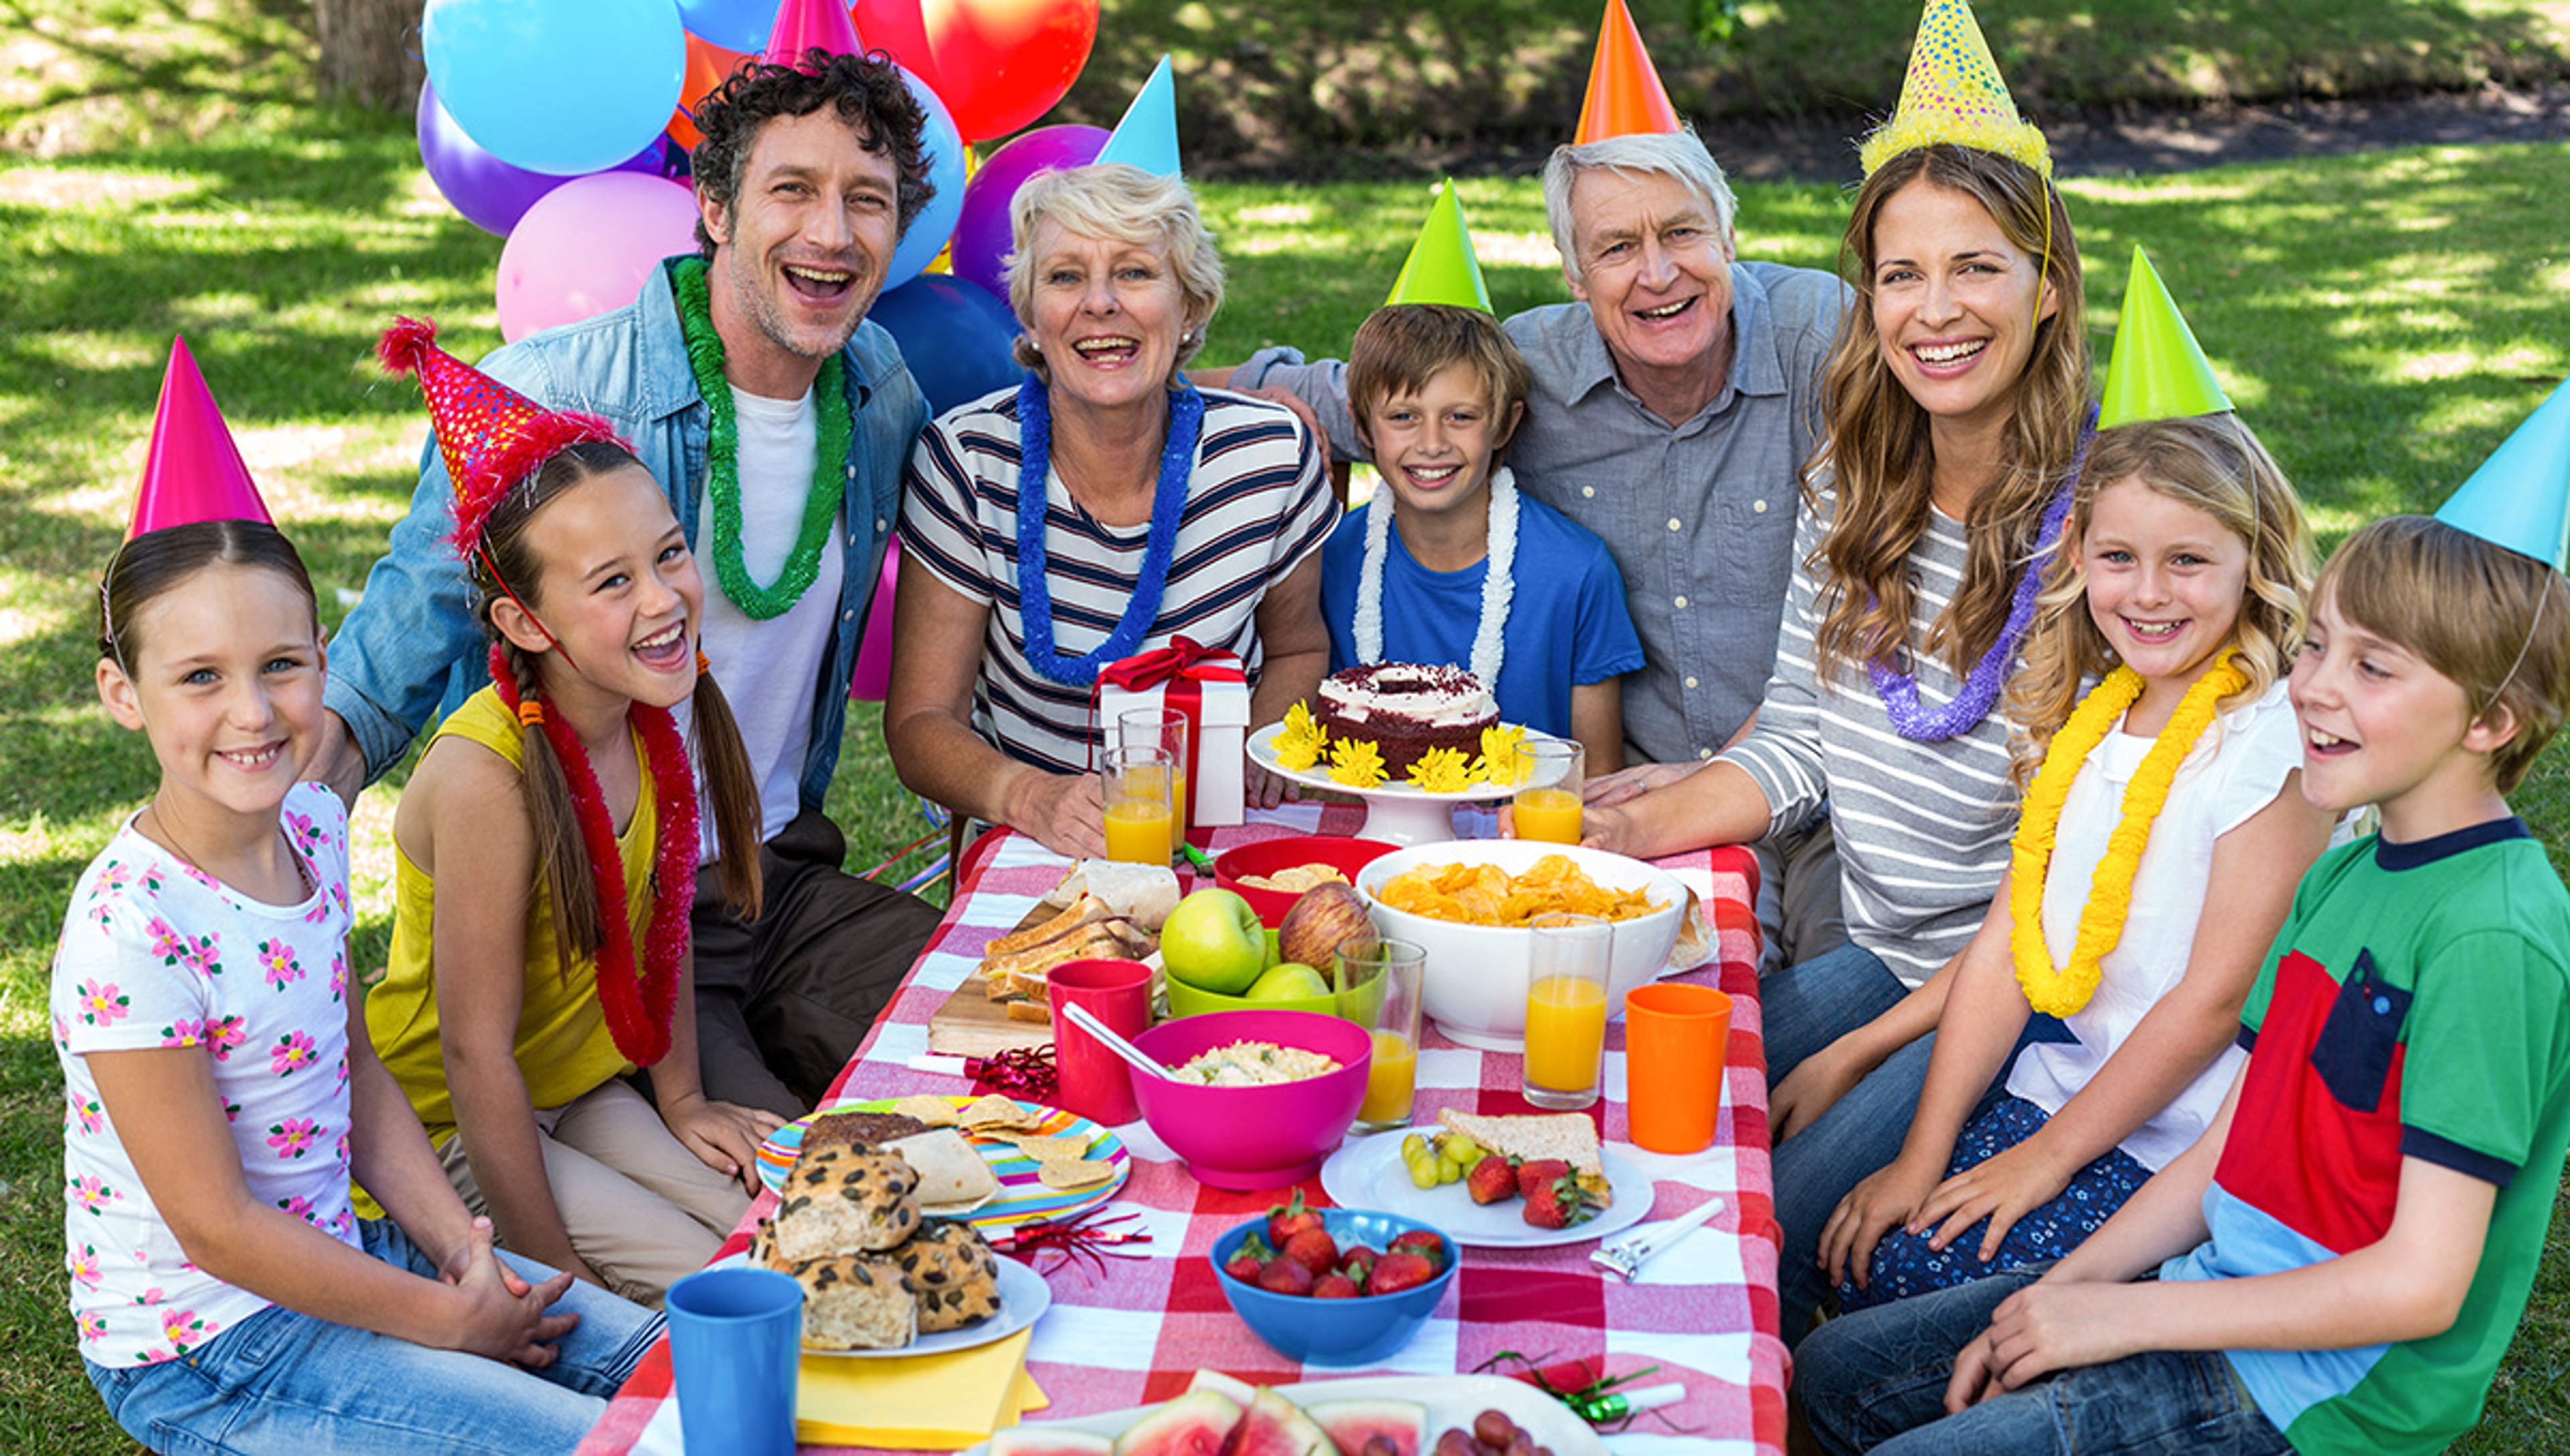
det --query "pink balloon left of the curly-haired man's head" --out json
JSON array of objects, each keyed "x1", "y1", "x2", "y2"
[{"x1": 499, "y1": 172, "x2": 697, "y2": 341}]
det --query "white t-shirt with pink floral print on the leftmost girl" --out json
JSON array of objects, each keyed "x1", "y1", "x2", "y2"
[{"x1": 49, "y1": 784, "x2": 357, "y2": 1366}]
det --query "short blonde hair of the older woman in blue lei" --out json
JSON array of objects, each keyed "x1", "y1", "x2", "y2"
[{"x1": 1000, "y1": 162, "x2": 1223, "y2": 387}]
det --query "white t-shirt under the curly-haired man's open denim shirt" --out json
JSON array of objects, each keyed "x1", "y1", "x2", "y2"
[{"x1": 679, "y1": 390, "x2": 848, "y2": 862}]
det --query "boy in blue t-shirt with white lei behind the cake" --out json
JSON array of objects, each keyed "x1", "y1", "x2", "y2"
[{"x1": 1321, "y1": 303, "x2": 1642, "y2": 778}]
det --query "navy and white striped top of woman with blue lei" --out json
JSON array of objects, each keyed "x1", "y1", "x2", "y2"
[{"x1": 902, "y1": 385, "x2": 1339, "y2": 773}]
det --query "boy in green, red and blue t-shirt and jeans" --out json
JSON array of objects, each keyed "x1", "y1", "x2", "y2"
[{"x1": 1794, "y1": 516, "x2": 2570, "y2": 1456}]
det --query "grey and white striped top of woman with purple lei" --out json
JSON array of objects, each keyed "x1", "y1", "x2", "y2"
[{"x1": 1722, "y1": 492, "x2": 2017, "y2": 986}]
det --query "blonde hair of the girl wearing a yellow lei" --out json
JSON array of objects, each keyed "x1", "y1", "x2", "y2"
[{"x1": 2007, "y1": 414, "x2": 2313, "y2": 788}]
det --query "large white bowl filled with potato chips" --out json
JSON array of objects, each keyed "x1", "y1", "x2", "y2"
[{"x1": 1357, "y1": 840, "x2": 1686, "y2": 1051}]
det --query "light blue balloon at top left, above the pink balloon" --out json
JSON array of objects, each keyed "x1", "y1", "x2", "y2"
[{"x1": 419, "y1": 0, "x2": 686, "y2": 177}]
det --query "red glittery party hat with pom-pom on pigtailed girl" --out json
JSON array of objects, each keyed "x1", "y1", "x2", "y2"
[{"x1": 375, "y1": 318, "x2": 624, "y2": 555}]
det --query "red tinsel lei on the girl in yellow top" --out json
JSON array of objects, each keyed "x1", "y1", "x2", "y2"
[{"x1": 491, "y1": 642, "x2": 697, "y2": 1066}]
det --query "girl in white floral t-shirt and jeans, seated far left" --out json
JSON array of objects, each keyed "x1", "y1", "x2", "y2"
[{"x1": 69, "y1": 521, "x2": 658, "y2": 1456}]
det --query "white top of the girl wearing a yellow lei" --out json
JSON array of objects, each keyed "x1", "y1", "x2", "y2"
[{"x1": 2007, "y1": 683, "x2": 2303, "y2": 1171}]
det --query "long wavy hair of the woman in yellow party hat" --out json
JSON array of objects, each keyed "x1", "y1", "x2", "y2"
[{"x1": 1812, "y1": 144, "x2": 2089, "y2": 683}]
